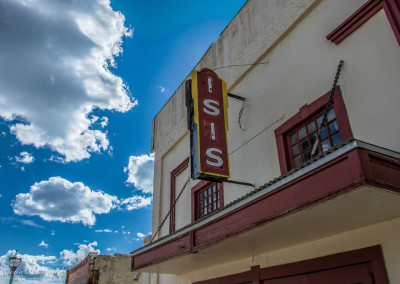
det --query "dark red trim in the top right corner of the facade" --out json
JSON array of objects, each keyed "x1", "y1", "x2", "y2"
[{"x1": 326, "y1": 0, "x2": 400, "y2": 46}]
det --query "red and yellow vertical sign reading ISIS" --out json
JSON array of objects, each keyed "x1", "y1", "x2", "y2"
[{"x1": 186, "y1": 68, "x2": 229, "y2": 181}]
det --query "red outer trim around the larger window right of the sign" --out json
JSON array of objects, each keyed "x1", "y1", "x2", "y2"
[{"x1": 275, "y1": 86, "x2": 353, "y2": 174}]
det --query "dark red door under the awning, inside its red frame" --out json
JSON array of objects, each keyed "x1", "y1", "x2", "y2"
[{"x1": 262, "y1": 263, "x2": 373, "y2": 284}]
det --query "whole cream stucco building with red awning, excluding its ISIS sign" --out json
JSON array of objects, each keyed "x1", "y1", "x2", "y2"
[{"x1": 131, "y1": 0, "x2": 400, "y2": 284}]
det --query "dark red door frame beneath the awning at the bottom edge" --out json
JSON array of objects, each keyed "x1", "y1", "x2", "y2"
[{"x1": 194, "y1": 245, "x2": 389, "y2": 284}]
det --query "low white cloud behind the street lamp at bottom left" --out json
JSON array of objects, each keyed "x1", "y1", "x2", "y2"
[{"x1": 0, "y1": 250, "x2": 66, "y2": 283}]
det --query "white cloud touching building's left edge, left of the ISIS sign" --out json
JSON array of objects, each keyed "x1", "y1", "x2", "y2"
[{"x1": 124, "y1": 153, "x2": 154, "y2": 193}]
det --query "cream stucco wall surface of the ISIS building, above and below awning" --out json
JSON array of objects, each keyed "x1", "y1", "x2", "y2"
[{"x1": 140, "y1": 0, "x2": 400, "y2": 283}]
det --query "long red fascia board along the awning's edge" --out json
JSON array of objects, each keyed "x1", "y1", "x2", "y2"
[{"x1": 133, "y1": 148, "x2": 400, "y2": 270}]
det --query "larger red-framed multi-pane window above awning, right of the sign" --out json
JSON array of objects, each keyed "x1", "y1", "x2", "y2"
[{"x1": 275, "y1": 87, "x2": 353, "y2": 174}]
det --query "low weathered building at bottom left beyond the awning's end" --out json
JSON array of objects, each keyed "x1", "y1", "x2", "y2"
[{"x1": 65, "y1": 253, "x2": 137, "y2": 284}]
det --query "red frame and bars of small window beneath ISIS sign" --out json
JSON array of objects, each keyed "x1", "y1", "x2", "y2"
[{"x1": 192, "y1": 181, "x2": 224, "y2": 222}]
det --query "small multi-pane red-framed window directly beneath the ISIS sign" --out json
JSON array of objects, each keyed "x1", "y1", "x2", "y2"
[{"x1": 192, "y1": 181, "x2": 224, "y2": 221}]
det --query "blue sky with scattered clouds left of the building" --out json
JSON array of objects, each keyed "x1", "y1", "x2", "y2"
[{"x1": 0, "y1": 0, "x2": 246, "y2": 284}]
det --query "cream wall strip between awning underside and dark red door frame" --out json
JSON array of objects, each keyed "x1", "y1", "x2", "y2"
[{"x1": 180, "y1": 219, "x2": 400, "y2": 284}]
